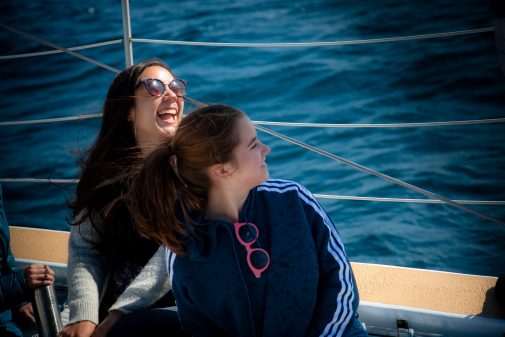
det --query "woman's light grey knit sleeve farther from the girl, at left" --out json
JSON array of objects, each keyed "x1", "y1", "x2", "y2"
[{"x1": 67, "y1": 222, "x2": 108, "y2": 324}]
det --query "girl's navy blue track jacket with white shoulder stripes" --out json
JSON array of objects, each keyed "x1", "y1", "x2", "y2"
[{"x1": 166, "y1": 179, "x2": 359, "y2": 337}]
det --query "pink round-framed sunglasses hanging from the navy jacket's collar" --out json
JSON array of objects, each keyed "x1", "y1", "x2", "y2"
[{"x1": 233, "y1": 222, "x2": 270, "y2": 278}]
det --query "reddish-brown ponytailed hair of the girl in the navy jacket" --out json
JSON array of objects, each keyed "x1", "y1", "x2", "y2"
[{"x1": 126, "y1": 105, "x2": 245, "y2": 255}]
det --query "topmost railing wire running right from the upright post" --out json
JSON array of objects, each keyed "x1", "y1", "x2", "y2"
[{"x1": 131, "y1": 27, "x2": 494, "y2": 48}]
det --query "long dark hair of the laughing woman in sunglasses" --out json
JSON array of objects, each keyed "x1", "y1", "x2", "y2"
[{"x1": 69, "y1": 60, "x2": 172, "y2": 256}]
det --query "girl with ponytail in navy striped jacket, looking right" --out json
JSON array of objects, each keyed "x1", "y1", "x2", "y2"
[{"x1": 127, "y1": 105, "x2": 366, "y2": 337}]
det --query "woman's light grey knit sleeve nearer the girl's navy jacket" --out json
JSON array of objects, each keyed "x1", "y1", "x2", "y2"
[{"x1": 109, "y1": 246, "x2": 171, "y2": 314}]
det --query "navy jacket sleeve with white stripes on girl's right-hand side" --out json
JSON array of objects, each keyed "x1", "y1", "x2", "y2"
[{"x1": 306, "y1": 191, "x2": 359, "y2": 337}]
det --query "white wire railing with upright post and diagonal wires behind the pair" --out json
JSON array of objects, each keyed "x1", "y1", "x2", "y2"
[{"x1": 0, "y1": 0, "x2": 505, "y2": 225}]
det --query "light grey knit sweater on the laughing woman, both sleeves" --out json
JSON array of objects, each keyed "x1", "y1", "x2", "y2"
[{"x1": 67, "y1": 219, "x2": 171, "y2": 324}]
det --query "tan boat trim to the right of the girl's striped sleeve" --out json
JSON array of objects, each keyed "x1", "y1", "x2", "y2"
[{"x1": 352, "y1": 263, "x2": 505, "y2": 319}]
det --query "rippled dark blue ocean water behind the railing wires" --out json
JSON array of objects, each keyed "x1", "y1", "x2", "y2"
[{"x1": 0, "y1": 0, "x2": 505, "y2": 275}]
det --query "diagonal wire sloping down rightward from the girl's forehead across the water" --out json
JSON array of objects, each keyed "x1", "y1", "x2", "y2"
[{"x1": 255, "y1": 125, "x2": 505, "y2": 226}]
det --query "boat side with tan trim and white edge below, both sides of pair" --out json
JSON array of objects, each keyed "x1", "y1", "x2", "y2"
[{"x1": 10, "y1": 226, "x2": 505, "y2": 337}]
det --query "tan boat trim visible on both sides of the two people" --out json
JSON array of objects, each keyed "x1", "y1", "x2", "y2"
[{"x1": 10, "y1": 226, "x2": 505, "y2": 319}]
